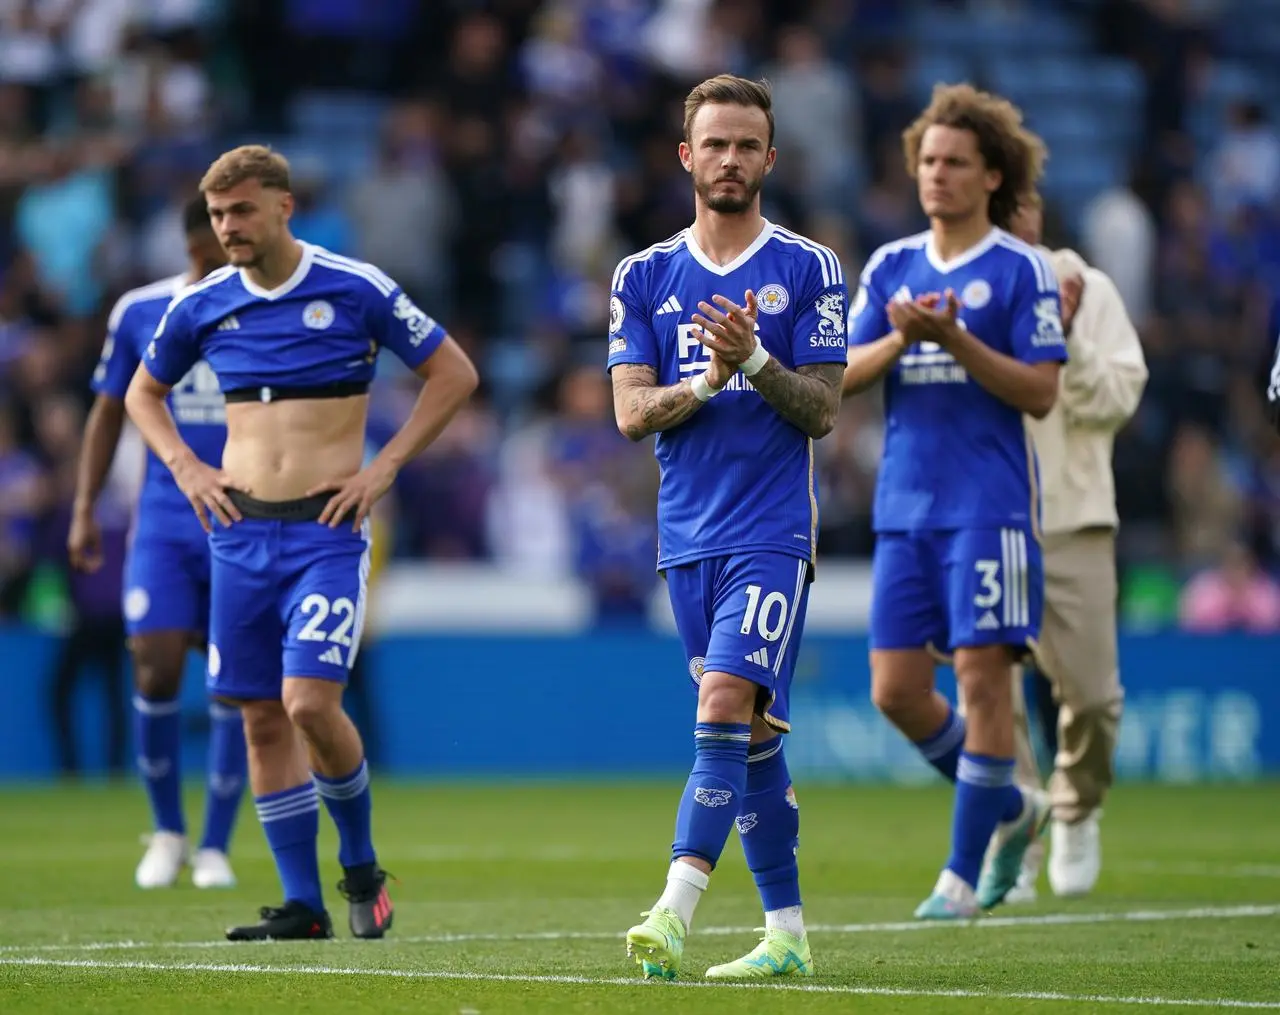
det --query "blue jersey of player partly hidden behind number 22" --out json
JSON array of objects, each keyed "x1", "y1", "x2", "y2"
[{"x1": 92, "y1": 268, "x2": 227, "y2": 543}]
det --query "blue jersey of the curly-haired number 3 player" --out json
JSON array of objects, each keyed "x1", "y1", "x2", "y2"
[{"x1": 849, "y1": 229, "x2": 1066, "y2": 532}]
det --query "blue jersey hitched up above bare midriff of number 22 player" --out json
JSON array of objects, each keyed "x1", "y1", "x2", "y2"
[{"x1": 145, "y1": 243, "x2": 444, "y2": 399}]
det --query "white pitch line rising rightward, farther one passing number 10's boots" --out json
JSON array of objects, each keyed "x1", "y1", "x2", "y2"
[{"x1": 0, "y1": 905, "x2": 1280, "y2": 955}]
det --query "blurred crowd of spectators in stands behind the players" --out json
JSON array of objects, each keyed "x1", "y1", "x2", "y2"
[{"x1": 0, "y1": 0, "x2": 1280, "y2": 630}]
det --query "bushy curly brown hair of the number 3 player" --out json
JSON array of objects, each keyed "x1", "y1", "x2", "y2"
[{"x1": 902, "y1": 84, "x2": 1048, "y2": 229}]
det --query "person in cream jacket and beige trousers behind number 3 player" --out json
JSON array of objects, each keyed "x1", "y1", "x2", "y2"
[{"x1": 1006, "y1": 195, "x2": 1147, "y2": 901}]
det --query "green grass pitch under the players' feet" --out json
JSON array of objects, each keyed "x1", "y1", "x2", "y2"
[{"x1": 0, "y1": 779, "x2": 1280, "y2": 1015}]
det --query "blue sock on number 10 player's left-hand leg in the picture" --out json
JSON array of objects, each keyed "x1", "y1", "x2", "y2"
[{"x1": 671, "y1": 722, "x2": 751, "y2": 868}]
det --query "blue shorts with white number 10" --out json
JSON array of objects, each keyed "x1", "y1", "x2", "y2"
[{"x1": 666, "y1": 553, "x2": 810, "y2": 733}]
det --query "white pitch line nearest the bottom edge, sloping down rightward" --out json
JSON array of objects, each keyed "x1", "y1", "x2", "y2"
[{"x1": 0, "y1": 957, "x2": 1280, "y2": 1011}]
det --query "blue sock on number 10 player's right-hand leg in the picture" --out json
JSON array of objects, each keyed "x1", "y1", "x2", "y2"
[{"x1": 737, "y1": 736, "x2": 800, "y2": 913}]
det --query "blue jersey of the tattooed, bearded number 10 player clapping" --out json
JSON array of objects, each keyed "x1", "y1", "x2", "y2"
[{"x1": 608, "y1": 223, "x2": 847, "y2": 568}]
